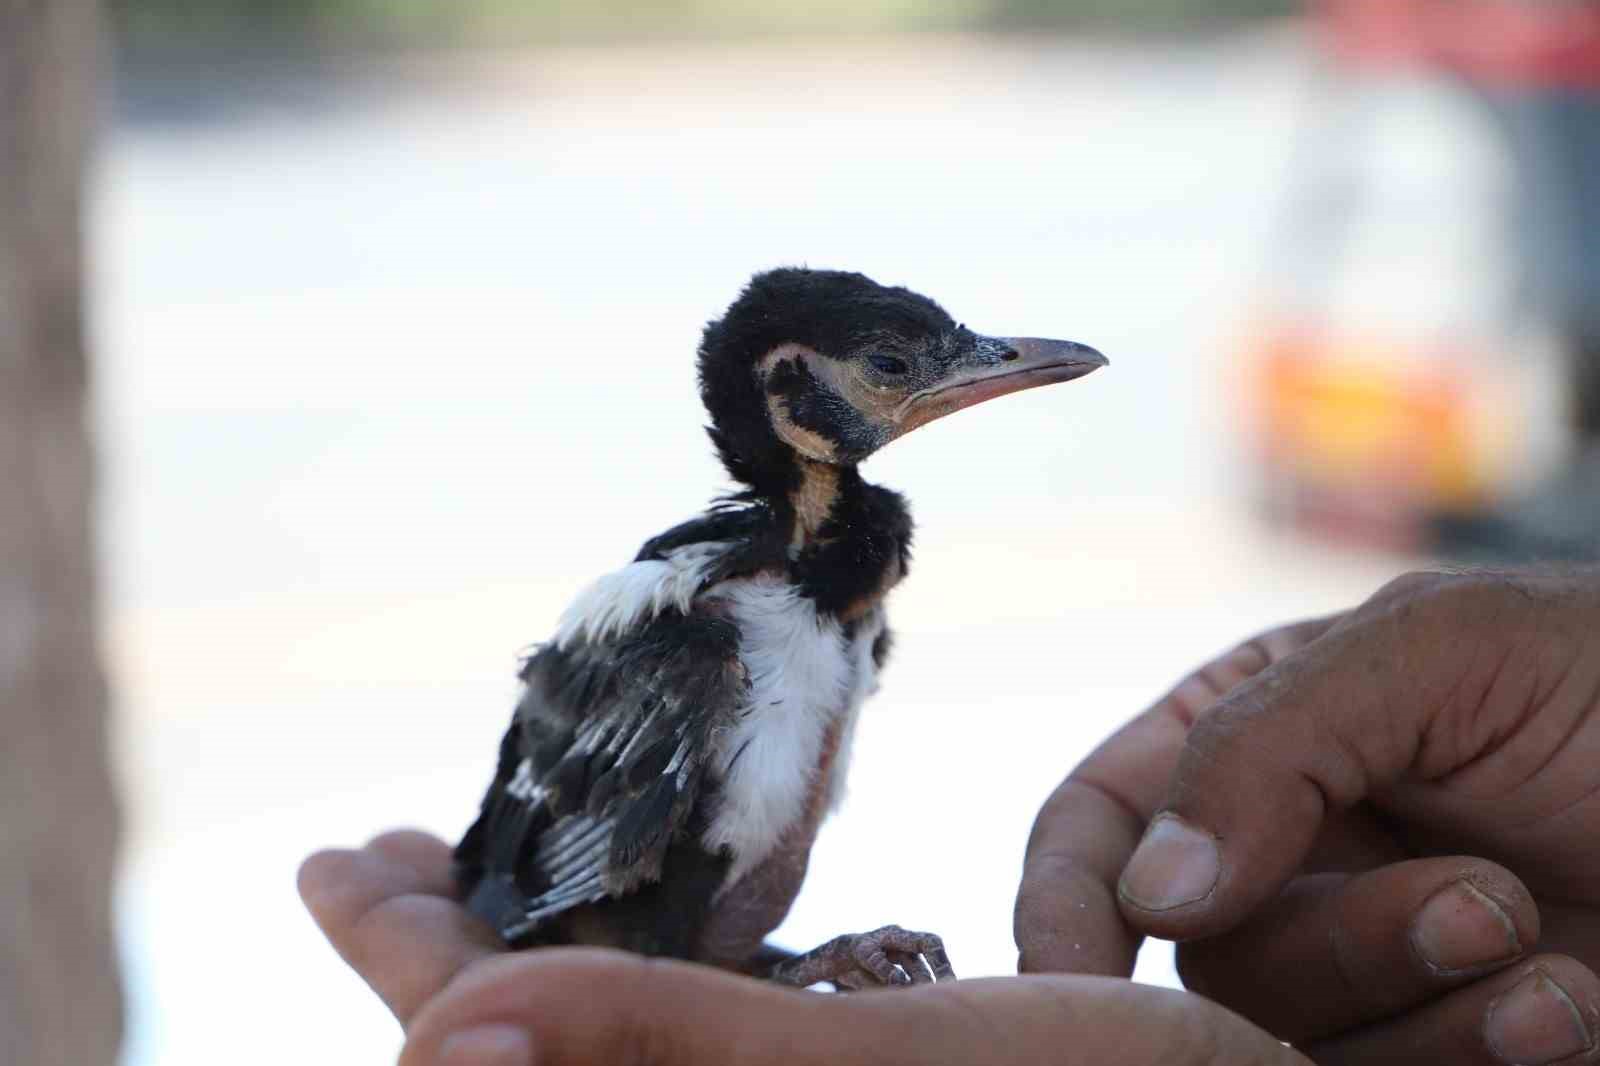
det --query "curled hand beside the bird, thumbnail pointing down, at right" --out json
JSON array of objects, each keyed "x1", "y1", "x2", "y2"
[{"x1": 1016, "y1": 571, "x2": 1600, "y2": 1063}]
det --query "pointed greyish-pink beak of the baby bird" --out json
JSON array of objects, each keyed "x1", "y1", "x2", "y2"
[{"x1": 894, "y1": 336, "x2": 1110, "y2": 437}]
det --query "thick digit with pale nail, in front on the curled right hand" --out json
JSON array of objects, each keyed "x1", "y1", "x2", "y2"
[{"x1": 1118, "y1": 576, "x2": 1538, "y2": 940}]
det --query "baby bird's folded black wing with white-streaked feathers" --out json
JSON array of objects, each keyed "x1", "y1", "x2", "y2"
[{"x1": 456, "y1": 611, "x2": 749, "y2": 940}]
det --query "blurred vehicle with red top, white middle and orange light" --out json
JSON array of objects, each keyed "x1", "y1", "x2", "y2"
[{"x1": 1243, "y1": 0, "x2": 1600, "y2": 551}]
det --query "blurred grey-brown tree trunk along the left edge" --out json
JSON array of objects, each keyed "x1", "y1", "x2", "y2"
[{"x1": 0, "y1": 0, "x2": 122, "y2": 1066}]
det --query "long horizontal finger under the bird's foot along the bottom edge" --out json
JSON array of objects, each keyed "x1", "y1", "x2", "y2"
[{"x1": 400, "y1": 949, "x2": 1304, "y2": 1066}]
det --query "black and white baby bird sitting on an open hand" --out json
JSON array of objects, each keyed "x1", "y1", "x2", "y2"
[{"x1": 456, "y1": 269, "x2": 1106, "y2": 989}]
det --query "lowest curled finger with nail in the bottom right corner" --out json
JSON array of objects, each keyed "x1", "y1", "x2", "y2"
[{"x1": 1307, "y1": 956, "x2": 1600, "y2": 1066}]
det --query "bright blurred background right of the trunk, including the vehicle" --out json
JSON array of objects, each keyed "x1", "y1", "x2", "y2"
[{"x1": 0, "y1": 0, "x2": 1600, "y2": 1066}]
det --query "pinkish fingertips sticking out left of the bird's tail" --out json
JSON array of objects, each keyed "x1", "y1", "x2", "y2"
[{"x1": 299, "y1": 837, "x2": 504, "y2": 1024}]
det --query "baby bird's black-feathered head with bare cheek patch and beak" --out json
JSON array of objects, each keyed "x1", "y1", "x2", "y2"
[{"x1": 699, "y1": 269, "x2": 1106, "y2": 493}]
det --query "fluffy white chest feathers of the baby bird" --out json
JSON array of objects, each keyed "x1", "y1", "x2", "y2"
[{"x1": 702, "y1": 578, "x2": 883, "y2": 890}]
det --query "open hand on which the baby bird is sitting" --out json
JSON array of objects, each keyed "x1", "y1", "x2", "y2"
[{"x1": 299, "y1": 832, "x2": 1306, "y2": 1066}]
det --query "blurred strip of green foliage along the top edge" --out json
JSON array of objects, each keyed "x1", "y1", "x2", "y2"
[{"x1": 110, "y1": 0, "x2": 1302, "y2": 46}]
